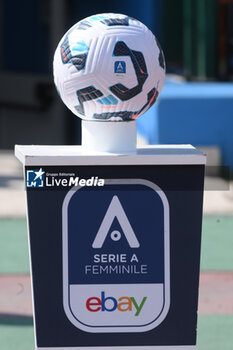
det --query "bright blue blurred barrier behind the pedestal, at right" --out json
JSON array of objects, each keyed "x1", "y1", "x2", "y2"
[{"x1": 138, "y1": 82, "x2": 233, "y2": 169}]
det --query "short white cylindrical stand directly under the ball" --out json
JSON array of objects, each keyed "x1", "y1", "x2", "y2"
[{"x1": 82, "y1": 120, "x2": 137, "y2": 154}]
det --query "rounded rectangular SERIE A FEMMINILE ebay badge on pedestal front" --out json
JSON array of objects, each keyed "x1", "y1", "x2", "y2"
[{"x1": 63, "y1": 179, "x2": 170, "y2": 333}]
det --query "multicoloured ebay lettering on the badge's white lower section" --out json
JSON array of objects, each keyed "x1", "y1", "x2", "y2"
[{"x1": 86, "y1": 291, "x2": 147, "y2": 316}]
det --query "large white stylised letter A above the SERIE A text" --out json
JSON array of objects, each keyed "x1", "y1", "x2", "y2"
[{"x1": 92, "y1": 196, "x2": 140, "y2": 248}]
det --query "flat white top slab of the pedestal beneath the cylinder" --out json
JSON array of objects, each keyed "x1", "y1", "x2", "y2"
[{"x1": 15, "y1": 145, "x2": 206, "y2": 166}]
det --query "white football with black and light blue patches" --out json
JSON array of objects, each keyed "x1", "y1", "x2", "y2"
[{"x1": 53, "y1": 13, "x2": 165, "y2": 121}]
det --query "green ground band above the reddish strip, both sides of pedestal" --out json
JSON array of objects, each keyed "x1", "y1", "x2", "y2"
[{"x1": 0, "y1": 216, "x2": 233, "y2": 274}]
